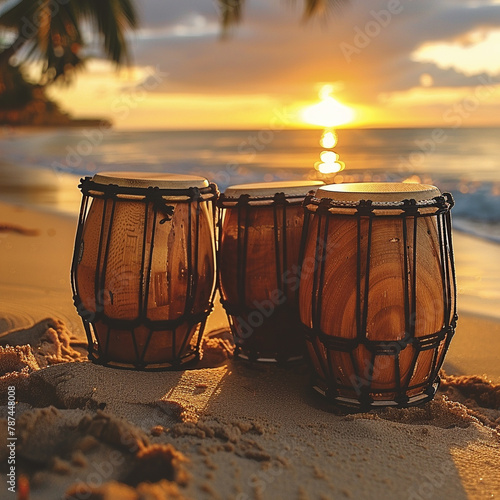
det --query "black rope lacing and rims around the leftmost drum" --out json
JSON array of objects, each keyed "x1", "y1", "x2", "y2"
[{"x1": 71, "y1": 172, "x2": 219, "y2": 371}]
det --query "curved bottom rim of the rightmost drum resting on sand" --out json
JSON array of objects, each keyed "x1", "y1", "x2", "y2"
[{"x1": 311, "y1": 376, "x2": 441, "y2": 412}]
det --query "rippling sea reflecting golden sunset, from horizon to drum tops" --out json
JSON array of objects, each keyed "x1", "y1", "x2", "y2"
[{"x1": 0, "y1": 129, "x2": 500, "y2": 243}]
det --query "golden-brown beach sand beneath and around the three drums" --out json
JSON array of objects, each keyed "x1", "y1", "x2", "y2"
[{"x1": 0, "y1": 200, "x2": 500, "y2": 500}]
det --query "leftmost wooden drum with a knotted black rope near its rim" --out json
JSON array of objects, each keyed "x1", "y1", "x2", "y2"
[{"x1": 72, "y1": 172, "x2": 218, "y2": 369}]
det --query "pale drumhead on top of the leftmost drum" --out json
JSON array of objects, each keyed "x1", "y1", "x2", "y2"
[{"x1": 92, "y1": 172, "x2": 209, "y2": 189}]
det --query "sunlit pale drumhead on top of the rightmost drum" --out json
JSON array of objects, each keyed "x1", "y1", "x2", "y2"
[{"x1": 316, "y1": 182, "x2": 441, "y2": 202}]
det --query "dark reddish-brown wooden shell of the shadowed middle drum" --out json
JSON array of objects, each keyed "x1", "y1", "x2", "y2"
[{"x1": 219, "y1": 205, "x2": 304, "y2": 359}]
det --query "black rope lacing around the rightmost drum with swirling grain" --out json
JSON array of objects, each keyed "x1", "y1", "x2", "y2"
[{"x1": 301, "y1": 188, "x2": 457, "y2": 410}]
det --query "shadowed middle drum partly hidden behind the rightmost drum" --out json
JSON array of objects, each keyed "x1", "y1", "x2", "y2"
[{"x1": 218, "y1": 181, "x2": 323, "y2": 361}]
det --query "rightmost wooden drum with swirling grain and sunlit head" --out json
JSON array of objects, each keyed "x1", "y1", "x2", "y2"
[{"x1": 300, "y1": 183, "x2": 457, "y2": 409}]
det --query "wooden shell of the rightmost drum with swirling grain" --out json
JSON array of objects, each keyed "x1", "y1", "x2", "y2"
[{"x1": 300, "y1": 184, "x2": 455, "y2": 406}]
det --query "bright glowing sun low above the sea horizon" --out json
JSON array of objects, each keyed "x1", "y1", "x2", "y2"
[{"x1": 301, "y1": 85, "x2": 355, "y2": 128}]
